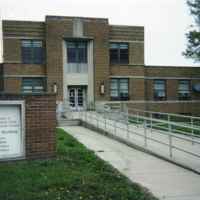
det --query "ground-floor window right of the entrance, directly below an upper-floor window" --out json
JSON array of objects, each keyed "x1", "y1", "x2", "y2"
[{"x1": 110, "y1": 79, "x2": 129, "y2": 100}]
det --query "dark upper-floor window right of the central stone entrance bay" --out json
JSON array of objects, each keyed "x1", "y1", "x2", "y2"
[{"x1": 110, "y1": 43, "x2": 129, "y2": 64}]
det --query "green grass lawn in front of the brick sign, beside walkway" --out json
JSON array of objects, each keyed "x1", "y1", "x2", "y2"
[{"x1": 0, "y1": 129, "x2": 156, "y2": 200}]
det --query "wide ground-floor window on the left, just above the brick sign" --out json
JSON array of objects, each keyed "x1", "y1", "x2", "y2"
[{"x1": 22, "y1": 78, "x2": 45, "y2": 93}]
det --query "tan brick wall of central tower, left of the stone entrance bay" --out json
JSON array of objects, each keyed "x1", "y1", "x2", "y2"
[{"x1": 46, "y1": 19, "x2": 73, "y2": 100}]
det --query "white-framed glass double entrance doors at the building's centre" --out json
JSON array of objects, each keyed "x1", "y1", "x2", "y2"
[{"x1": 68, "y1": 87, "x2": 86, "y2": 110}]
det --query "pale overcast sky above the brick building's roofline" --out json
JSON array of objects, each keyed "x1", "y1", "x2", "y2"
[{"x1": 0, "y1": 0, "x2": 199, "y2": 66}]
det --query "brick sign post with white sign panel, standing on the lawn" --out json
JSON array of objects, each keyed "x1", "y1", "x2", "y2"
[{"x1": 0, "y1": 94, "x2": 56, "y2": 161}]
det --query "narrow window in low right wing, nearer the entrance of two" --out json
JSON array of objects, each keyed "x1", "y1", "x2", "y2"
[{"x1": 154, "y1": 80, "x2": 166, "y2": 101}]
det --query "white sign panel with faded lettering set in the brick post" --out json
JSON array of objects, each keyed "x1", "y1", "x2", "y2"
[{"x1": 0, "y1": 102, "x2": 24, "y2": 159}]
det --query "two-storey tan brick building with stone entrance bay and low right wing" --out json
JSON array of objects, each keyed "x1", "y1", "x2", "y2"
[{"x1": 0, "y1": 16, "x2": 200, "y2": 115}]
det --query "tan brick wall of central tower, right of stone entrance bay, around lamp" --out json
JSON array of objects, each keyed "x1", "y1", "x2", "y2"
[{"x1": 84, "y1": 20, "x2": 110, "y2": 100}]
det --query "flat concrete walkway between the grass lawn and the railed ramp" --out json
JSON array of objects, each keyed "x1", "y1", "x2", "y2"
[{"x1": 62, "y1": 126, "x2": 200, "y2": 200}]
